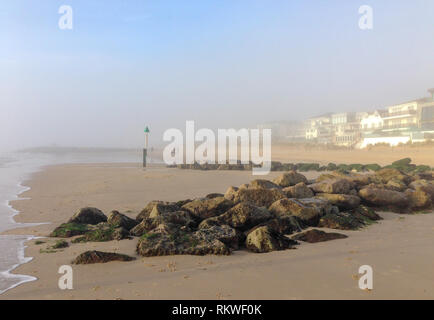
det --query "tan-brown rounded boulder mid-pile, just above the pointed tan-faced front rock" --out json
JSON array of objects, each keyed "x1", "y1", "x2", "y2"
[{"x1": 269, "y1": 198, "x2": 321, "y2": 226}]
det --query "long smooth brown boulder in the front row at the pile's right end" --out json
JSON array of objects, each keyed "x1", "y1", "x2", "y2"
[{"x1": 359, "y1": 188, "x2": 410, "y2": 209}]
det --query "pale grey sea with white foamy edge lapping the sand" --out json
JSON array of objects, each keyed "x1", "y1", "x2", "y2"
[{"x1": 0, "y1": 147, "x2": 160, "y2": 294}]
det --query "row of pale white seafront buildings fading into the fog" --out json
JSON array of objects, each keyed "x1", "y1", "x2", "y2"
[{"x1": 305, "y1": 89, "x2": 434, "y2": 147}]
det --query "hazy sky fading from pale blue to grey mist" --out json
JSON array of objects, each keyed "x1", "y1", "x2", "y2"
[{"x1": 0, "y1": 0, "x2": 434, "y2": 149}]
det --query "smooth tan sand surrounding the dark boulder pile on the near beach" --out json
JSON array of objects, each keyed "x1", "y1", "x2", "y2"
[{"x1": 0, "y1": 161, "x2": 434, "y2": 299}]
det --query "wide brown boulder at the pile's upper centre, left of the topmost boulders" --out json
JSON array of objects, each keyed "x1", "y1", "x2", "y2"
[{"x1": 234, "y1": 188, "x2": 285, "y2": 207}]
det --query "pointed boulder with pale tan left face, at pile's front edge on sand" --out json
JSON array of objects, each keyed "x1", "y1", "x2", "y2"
[{"x1": 246, "y1": 226, "x2": 297, "y2": 253}]
